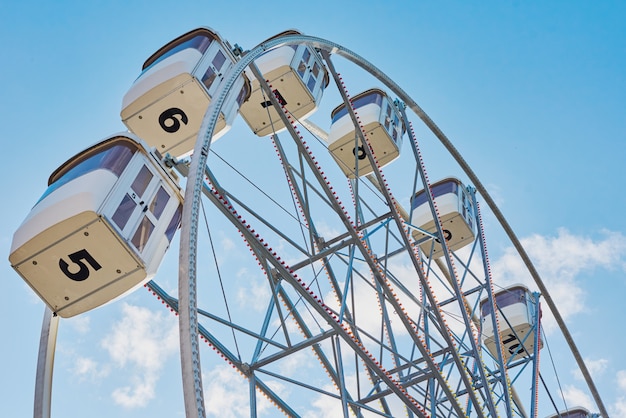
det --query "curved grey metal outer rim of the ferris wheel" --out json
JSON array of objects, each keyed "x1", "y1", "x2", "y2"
[{"x1": 174, "y1": 31, "x2": 606, "y2": 417}]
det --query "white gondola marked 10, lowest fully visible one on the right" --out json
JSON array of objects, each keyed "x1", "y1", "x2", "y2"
[{"x1": 480, "y1": 284, "x2": 543, "y2": 361}]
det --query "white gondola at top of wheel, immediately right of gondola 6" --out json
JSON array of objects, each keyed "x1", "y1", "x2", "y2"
[{"x1": 239, "y1": 30, "x2": 329, "y2": 136}]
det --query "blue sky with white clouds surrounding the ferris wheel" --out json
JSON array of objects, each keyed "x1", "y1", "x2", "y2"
[{"x1": 0, "y1": 0, "x2": 626, "y2": 417}]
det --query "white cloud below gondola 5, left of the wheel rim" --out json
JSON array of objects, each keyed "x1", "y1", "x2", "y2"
[{"x1": 101, "y1": 303, "x2": 178, "y2": 408}]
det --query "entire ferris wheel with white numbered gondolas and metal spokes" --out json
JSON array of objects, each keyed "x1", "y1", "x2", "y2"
[{"x1": 11, "y1": 28, "x2": 607, "y2": 417}]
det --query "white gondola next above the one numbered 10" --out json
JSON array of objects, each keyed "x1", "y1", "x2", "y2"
[{"x1": 410, "y1": 178, "x2": 476, "y2": 258}]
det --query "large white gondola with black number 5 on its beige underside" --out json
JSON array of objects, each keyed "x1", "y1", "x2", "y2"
[{"x1": 9, "y1": 133, "x2": 182, "y2": 317}]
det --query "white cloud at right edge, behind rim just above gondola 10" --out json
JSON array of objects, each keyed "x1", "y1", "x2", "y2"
[{"x1": 492, "y1": 229, "x2": 626, "y2": 331}]
